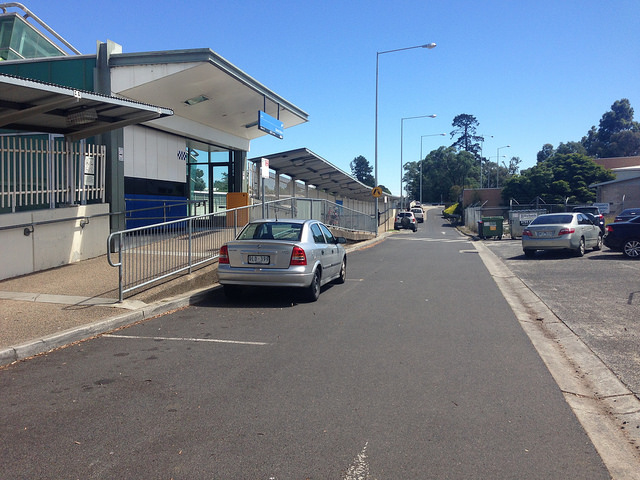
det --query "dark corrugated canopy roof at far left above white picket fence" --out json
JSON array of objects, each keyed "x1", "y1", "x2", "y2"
[{"x1": 0, "y1": 74, "x2": 173, "y2": 141}]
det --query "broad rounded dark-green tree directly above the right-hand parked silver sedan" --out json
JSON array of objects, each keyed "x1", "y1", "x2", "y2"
[{"x1": 502, "y1": 153, "x2": 614, "y2": 203}]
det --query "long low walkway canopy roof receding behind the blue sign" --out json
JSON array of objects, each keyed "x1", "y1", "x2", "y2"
[{"x1": 249, "y1": 148, "x2": 374, "y2": 201}]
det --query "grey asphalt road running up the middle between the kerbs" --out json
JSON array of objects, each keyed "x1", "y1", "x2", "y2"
[{"x1": 0, "y1": 212, "x2": 610, "y2": 480}]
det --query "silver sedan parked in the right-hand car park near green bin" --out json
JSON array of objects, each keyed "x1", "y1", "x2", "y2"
[{"x1": 522, "y1": 212, "x2": 602, "y2": 257}]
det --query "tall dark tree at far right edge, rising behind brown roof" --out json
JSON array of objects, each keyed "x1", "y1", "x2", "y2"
[{"x1": 581, "y1": 98, "x2": 640, "y2": 158}]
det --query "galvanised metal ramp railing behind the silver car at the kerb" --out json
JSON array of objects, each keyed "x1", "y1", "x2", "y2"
[{"x1": 107, "y1": 198, "x2": 377, "y2": 302}]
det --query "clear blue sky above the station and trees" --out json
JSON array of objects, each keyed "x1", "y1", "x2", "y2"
[{"x1": 22, "y1": 0, "x2": 640, "y2": 194}]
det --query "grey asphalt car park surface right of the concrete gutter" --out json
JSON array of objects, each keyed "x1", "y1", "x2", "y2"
[{"x1": 483, "y1": 233, "x2": 640, "y2": 398}]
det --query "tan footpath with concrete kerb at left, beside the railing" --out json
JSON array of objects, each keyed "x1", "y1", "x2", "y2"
[{"x1": 0, "y1": 256, "x2": 218, "y2": 366}]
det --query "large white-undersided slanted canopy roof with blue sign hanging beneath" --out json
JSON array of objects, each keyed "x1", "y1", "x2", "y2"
[{"x1": 109, "y1": 48, "x2": 308, "y2": 140}]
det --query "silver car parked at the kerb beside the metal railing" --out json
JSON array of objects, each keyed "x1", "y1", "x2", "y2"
[{"x1": 218, "y1": 219, "x2": 347, "y2": 301}]
